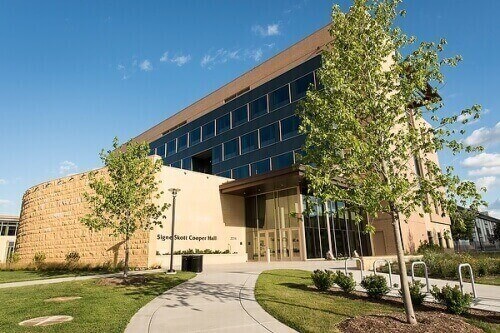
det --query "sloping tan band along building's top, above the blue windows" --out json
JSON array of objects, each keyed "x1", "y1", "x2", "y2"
[{"x1": 132, "y1": 24, "x2": 331, "y2": 142}]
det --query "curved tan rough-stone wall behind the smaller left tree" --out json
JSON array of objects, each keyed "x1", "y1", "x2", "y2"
[{"x1": 16, "y1": 173, "x2": 149, "y2": 267}]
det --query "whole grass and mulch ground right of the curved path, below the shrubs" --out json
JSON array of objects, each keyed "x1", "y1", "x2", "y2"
[{"x1": 255, "y1": 270, "x2": 500, "y2": 333}]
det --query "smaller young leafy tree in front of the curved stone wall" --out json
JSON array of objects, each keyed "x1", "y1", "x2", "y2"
[{"x1": 81, "y1": 138, "x2": 169, "y2": 277}]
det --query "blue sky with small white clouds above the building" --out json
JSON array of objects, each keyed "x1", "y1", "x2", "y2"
[{"x1": 0, "y1": 0, "x2": 500, "y2": 216}]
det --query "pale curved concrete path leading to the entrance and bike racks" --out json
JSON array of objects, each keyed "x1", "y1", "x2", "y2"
[{"x1": 125, "y1": 261, "x2": 500, "y2": 333}]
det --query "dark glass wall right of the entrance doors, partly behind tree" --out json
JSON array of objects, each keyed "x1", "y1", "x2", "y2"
[{"x1": 302, "y1": 195, "x2": 371, "y2": 259}]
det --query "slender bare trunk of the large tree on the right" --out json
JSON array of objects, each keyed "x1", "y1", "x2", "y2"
[{"x1": 391, "y1": 205, "x2": 417, "y2": 325}]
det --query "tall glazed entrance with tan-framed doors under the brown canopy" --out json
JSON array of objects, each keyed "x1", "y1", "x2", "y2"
[{"x1": 245, "y1": 188, "x2": 300, "y2": 261}]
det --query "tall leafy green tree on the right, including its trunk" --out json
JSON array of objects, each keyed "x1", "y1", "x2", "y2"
[{"x1": 298, "y1": 0, "x2": 483, "y2": 324}]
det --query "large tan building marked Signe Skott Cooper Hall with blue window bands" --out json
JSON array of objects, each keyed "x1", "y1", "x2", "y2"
[{"x1": 14, "y1": 27, "x2": 453, "y2": 266}]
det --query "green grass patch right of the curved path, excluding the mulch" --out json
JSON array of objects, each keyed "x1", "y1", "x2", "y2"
[{"x1": 255, "y1": 270, "x2": 500, "y2": 333}]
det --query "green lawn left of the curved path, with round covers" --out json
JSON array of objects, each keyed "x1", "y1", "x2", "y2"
[{"x1": 0, "y1": 272, "x2": 195, "y2": 333}]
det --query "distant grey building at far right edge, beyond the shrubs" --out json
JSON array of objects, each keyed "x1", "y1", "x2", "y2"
[{"x1": 455, "y1": 212, "x2": 500, "y2": 251}]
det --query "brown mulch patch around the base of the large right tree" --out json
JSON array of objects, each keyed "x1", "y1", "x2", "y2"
[{"x1": 339, "y1": 312, "x2": 483, "y2": 333}]
